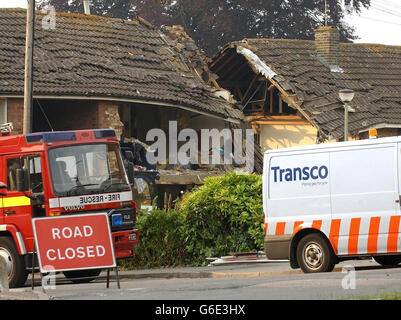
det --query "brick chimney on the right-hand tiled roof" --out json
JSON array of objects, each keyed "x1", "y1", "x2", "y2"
[{"x1": 315, "y1": 26, "x2": 340, "y2": 71}]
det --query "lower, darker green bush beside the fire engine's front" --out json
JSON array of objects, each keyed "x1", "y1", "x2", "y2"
[{"x1": 119, "y1": 210, "x2": 186, "y2": 269}]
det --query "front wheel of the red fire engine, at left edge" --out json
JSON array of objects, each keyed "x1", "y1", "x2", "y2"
[{"x1": 0, "y1": 237, "x2": 28, "y2": 288}]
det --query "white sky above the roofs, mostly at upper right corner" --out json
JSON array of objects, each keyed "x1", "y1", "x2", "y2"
[{"x1": 0, "y1": 0, "x2": 401, "y2": 46}]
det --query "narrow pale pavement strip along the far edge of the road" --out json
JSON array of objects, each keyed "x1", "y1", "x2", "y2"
[{"x1": 0, "y1": 259, "x2": 379, "y2": 300}]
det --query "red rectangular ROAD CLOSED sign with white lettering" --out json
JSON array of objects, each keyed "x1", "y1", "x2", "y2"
[{"x1": 32, "y1": 213, "x2": 116, "y2": 273}]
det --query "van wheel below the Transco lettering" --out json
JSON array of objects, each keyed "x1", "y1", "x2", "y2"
[{"x1": 297, "y1": 233, "x2": 336, "y2": 273}]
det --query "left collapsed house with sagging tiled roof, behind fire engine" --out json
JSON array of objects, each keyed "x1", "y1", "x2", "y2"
[{"x1": 0, "y1": 9, "x2": 255, "y2": 209}]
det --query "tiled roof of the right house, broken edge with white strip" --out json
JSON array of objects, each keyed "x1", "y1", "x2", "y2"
[{"x1": 210, "y1": 39, "x2": 401, "y2": 139}]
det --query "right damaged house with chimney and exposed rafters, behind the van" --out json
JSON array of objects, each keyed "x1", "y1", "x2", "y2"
[{"x1": 209, "y1": 26, "x2": 401, "y2": 150}]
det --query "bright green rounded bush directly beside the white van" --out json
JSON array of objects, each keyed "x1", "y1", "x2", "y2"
[{"x1": 178, "y1": 172, "x2": 263, "y2": 265}]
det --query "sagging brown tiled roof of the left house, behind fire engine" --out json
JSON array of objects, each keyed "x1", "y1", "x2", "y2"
[{"x1": 0, "y1": 9, "x2": 242, "y2": 119}]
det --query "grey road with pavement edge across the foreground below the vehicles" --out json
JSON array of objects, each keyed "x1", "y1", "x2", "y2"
[{"x1": 6, "y1": 260, "x2": 401, "y2": 302}]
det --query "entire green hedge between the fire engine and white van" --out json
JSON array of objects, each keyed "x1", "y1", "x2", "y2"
[{"x1": 120, "y1": 172, "x2": 264, "y2": 269}]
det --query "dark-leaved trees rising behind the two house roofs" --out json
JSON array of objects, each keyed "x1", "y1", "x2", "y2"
[{"x1": 40, "y1": 0, "x2": 370, "y2": 55}]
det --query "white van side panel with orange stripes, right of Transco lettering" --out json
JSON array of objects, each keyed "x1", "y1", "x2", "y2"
[{"x1": 330, "y1": 143, "x2": 400, "y2": 255}]
